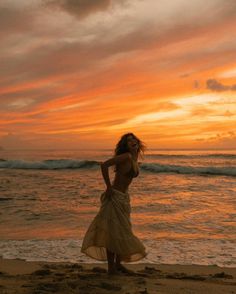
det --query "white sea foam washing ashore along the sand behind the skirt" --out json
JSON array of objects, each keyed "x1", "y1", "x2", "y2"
[{"x1": 0, "y1": 239, "x2": 236, "y2": 267}]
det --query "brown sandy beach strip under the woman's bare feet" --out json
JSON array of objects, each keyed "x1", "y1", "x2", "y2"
[{"x1": 0, "y1": 259, "x2": 236, "y2": 294}]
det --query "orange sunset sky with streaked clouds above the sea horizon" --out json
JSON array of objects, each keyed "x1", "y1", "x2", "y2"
[{"x1": 0, "y1": 0, "x2": 236, "y2": 149}]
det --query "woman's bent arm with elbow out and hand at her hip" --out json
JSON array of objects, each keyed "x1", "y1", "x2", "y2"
[{"x1": 101, "y1": 152, "x2": 131, "y2": 189}]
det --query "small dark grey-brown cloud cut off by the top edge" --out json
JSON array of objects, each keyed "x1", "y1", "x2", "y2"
[{"x1": 45, "y1": 0, "x2": 111, "y2": 18}]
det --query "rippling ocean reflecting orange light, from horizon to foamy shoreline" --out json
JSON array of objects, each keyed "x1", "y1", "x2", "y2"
[{"x1": 0, "y1": 149, "x2": 236, "y2": 267}]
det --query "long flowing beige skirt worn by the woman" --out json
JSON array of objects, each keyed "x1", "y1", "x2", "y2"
[{"x1": 81, "y1": 189, "x2": 147, "y2": 262}]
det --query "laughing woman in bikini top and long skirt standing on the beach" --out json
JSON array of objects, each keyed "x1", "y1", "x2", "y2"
[{"x1": 81, "y1": 133, "x2": 146, "y2": 274}]
